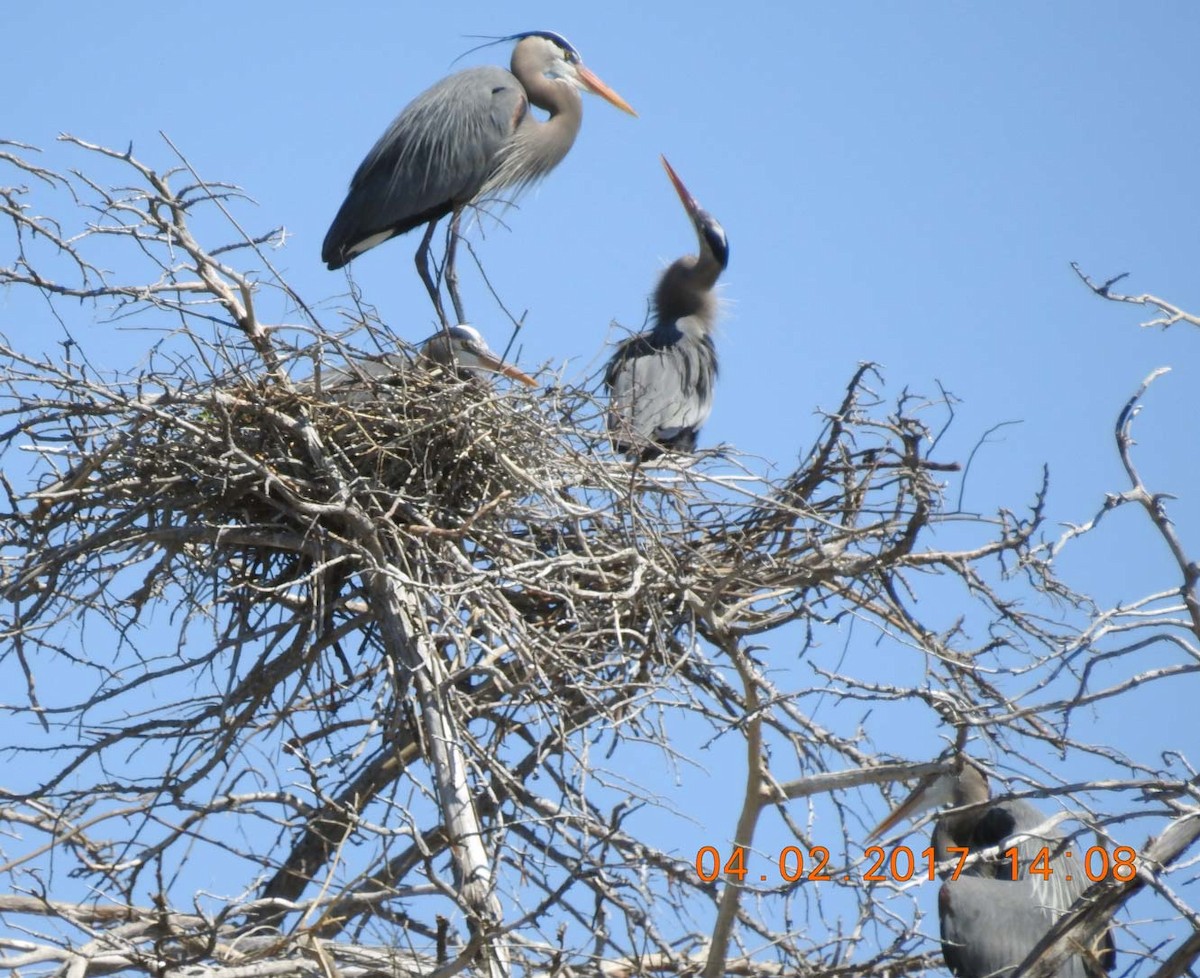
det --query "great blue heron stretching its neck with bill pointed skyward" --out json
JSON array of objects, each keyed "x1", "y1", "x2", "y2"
[{"x1": 604, "y1": 157, "x2": 730, "y2": 460}]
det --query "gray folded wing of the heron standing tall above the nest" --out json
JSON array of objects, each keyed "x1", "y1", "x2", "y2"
[{"x1": 322, "y1": 66, "x2": 528, "y2": 268}]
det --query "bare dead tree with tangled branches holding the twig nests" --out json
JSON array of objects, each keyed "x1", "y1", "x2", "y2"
[{"x1": 0, "y1": 139, "x2": 1200, "y2": 978}]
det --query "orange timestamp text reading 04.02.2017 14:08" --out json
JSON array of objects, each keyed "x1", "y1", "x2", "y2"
[{"x1": 696, "y1": 846, "x2": 1138, "y2": 883}]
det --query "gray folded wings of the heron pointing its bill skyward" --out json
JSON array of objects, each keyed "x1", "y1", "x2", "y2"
[{"x1": 605, "y1": 334, "x2": 715, "y2": 444}]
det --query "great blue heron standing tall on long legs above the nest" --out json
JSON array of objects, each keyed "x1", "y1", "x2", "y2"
[{"x1": 320, "y1": 30, "x2": 636, "y2": 325}]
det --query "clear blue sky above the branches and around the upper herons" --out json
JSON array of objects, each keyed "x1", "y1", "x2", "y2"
[{"x1": 0, "y1": 0, "x2": 1200, "y2": 969}]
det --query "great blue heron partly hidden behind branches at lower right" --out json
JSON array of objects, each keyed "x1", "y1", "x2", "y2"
[{"x1": 870, "y1": 755, "x2": 1116, "y2": 978}]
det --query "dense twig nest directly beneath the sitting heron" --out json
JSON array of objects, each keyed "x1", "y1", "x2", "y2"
[{"x1": 175, "y1": 356, "x2": 554, "y2": 532}]
